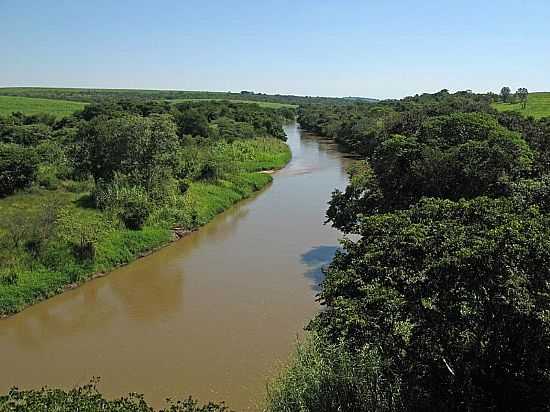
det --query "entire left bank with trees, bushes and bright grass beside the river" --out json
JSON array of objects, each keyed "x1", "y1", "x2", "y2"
[{"x1": 0, "y1": 100, "x2": 295, "y2": 316}]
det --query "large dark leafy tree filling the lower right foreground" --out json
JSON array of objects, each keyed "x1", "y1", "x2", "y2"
[{"x1": 311, "y1": 198, "x2": 550, "y2": 411}]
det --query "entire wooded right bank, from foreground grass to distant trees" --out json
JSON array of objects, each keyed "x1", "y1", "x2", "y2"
[{"x1": 268, "y1": 90, "x2": 550, "y2": 411}]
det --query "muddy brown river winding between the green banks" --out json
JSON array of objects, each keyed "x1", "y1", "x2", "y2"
[{"x1": 0, "y1": 124, "x2": 354, "y2": 411}]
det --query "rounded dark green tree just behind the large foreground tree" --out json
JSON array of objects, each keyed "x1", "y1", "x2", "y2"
[{"x1": 327, "y1": 113, "x2": 534, "y2": 232}]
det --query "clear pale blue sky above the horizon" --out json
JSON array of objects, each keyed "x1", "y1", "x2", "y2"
[{"x1": 0, "y1": 0, "x2": 550, "y2": 98}]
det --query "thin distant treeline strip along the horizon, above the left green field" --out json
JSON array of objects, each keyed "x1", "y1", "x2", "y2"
[{"x1": 0, "y1": 87, "x2": 376, "y2": 105}]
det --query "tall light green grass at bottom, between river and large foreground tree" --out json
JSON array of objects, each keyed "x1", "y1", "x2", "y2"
[{"x1": 264, "y1": 333, "x2": 400, "y2": 412}]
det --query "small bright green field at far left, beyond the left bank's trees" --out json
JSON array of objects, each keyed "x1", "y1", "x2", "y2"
[{"x1": 0, "y1": 96, "x2": 86, "y2": 118}]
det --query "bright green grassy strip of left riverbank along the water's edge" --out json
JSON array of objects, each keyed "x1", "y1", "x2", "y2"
[{"x1": 0, "y1": 139, "x2": 291, "y2": 318}]
